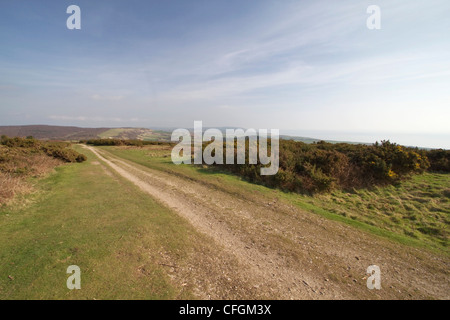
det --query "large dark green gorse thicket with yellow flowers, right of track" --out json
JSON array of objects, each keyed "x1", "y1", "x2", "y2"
[{"x1": 207, "y1": 140, "x2": 430, "y2": 193}]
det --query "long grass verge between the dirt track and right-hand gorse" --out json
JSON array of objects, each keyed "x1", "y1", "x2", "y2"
[{"x1": 102, "y1": 146, "x2": 450, "y2": 254}]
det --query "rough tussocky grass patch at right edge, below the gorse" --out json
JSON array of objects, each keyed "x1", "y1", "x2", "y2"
[{"x1": 298, "y1": 173, "x2": 450, "y2": 248}]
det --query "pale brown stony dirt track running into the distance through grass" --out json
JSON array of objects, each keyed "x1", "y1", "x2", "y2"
[{"x1": 83, "y1": 147, "x2": 450, "y2": 299}]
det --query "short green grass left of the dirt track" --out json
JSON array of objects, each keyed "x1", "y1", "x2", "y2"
[{"x1": 0, "y1": 146, "x2": 203, "y2": 299}]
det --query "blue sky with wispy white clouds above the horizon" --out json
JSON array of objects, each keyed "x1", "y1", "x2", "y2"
[{"x1": 0, "y1": 0, "x2": 450, "y2": 149}]
